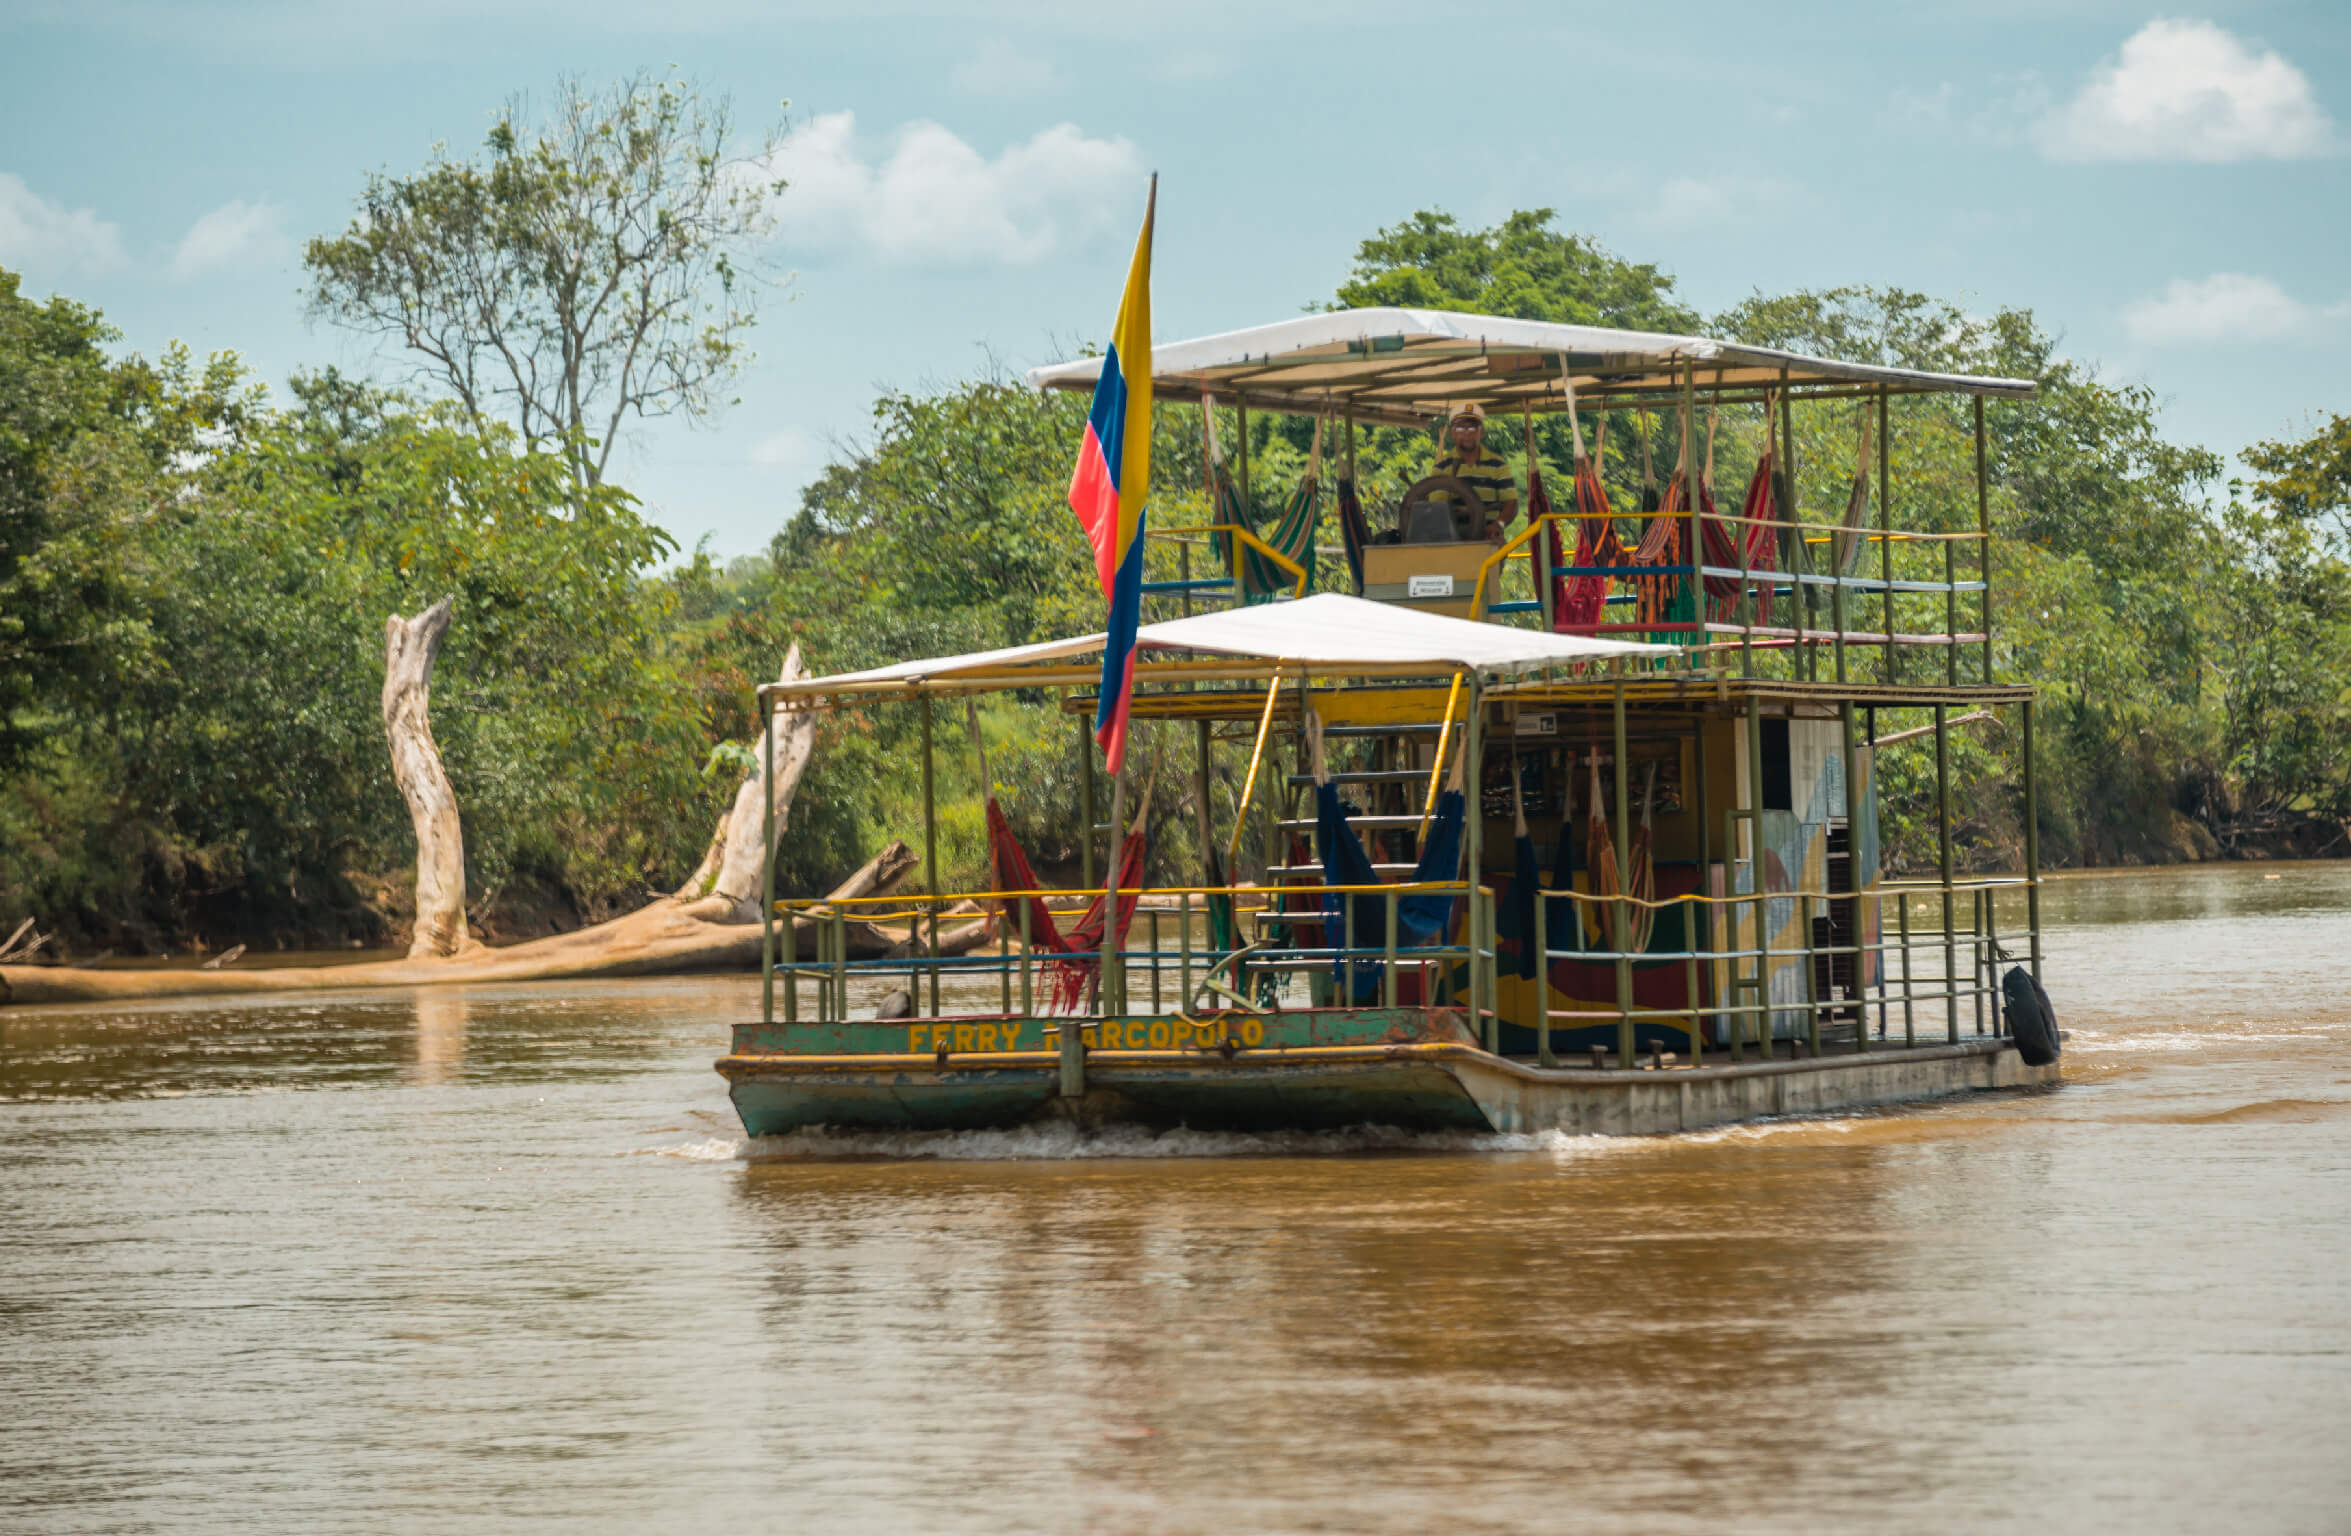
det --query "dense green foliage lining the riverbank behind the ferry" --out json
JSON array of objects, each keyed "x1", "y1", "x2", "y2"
[{"x1": 0, "y1": 212, "x2": 2351, "y2": 950}]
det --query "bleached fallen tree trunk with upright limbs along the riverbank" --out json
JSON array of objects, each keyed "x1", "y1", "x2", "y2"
[{"x1": 0, "y1": 635, "x2": 926, "y2": 1004}]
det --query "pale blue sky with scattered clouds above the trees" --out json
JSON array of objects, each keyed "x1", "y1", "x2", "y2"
[{"x1": 0, "y1": 0, "x2": 2351, "y2": 557}]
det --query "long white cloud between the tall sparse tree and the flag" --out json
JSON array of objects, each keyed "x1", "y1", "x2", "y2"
[{"x1": 773, "y1": 113, "x2": 1143, "y2": 266}]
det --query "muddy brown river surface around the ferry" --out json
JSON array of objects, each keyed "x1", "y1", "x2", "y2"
[{"x1": 0, "y1": 863, "x2": 2351, "y2": 1531}]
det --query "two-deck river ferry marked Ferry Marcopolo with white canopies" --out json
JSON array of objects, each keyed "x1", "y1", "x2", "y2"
[{"x1": 717, "y1": 308, "x2": 2059, "y2": 1136}]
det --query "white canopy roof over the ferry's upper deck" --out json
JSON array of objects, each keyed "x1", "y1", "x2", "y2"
[{"x1": 1027, "y1": 308, "x2": 2034, "y2": 426}]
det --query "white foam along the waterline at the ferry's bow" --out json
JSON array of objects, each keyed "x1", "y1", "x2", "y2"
[{"x1": 736, "y1": 1124, "x2": 1632, "y2": 1162}]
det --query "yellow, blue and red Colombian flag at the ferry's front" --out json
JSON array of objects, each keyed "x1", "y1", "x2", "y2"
[{"x1": 1070, "y1": 176, "x2": 1159, "y2": 774}]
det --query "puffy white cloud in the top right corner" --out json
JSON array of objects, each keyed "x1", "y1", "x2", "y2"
[{"x1": 2041, "y1": 21, "x2": 2335, "y2": 162}]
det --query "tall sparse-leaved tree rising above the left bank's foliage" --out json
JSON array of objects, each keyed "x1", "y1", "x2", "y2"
[{"x1": 303, "y1": 75, "x2": 783, "y2": 487}]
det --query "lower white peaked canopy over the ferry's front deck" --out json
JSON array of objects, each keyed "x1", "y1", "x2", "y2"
[{"x1": 762, "y1": 593, "x2": 1679, "y2": 699}]
